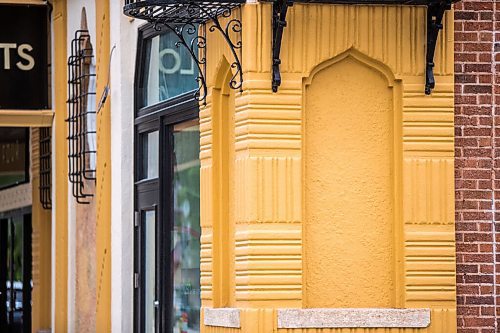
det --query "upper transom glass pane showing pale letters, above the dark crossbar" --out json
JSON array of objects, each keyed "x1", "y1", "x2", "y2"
[{"x1": 139, "y1": 31, "x2": 198, "y2": 107}]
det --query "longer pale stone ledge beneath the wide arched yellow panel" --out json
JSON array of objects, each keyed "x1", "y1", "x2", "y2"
[{"x1": 277, "y1": 308, "x2": 431, "y2": 328}]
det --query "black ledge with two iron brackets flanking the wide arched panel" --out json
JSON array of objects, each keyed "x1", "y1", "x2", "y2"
[{"x1": 272, "y1": 0, "x2": 456, "y2": 95}]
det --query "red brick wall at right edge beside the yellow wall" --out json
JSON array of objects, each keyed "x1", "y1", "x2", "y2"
[{"x1": 455, "y1": 0, "x2": 500, "y2": 333}]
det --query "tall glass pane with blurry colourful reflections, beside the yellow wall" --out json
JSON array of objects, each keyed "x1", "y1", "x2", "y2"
[{"x1": 171, "y1": 119, "x2": 201, "y2": 333}]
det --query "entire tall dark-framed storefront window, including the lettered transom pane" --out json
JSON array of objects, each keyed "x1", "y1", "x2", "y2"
[{"x1": 134, "y1": 26, "x2": 201, "y2": 333}]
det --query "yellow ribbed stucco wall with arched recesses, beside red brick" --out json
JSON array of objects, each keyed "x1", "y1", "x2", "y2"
[{"x1": 200, "y1": 3, "x2": 456, "y2": 333}]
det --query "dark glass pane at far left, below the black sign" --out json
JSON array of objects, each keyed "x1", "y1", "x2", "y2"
[{"x1": 0, "y1": 127, "x2": 29, "y2": 189}]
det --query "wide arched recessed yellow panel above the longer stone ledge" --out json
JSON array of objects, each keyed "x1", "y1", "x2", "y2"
[{"x1": 304, "y1": 54, "x2": 395, "y2": 307}]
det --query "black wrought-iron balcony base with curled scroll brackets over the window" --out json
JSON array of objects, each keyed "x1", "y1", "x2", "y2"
[{"x1": 123, "y1": 0, "x2": 245, "y2": 104}]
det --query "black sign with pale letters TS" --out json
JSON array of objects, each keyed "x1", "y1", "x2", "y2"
[{"x1": 0, "y1": 4, "x2": 49, "y2": 112}]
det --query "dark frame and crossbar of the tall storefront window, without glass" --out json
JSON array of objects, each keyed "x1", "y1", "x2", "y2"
[{"x1": 134, "y1": 24, "x2": 199, "y2": 333}]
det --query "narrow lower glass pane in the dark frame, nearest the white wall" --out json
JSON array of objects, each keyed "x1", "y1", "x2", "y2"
[{"x1": 142, "y1": 210, "x2": 156, "y2": 333}]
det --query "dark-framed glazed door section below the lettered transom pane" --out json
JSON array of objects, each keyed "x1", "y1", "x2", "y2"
[{"x1": 135, "y1": 108, "x2": 201, "y2": 333}]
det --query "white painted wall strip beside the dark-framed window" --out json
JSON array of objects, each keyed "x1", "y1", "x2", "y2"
[{"x1": 110, "y1": 1, "x2": 143, "y2": 333}]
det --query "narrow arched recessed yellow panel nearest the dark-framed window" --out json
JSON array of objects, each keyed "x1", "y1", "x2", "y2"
[{"x1": 211, "y1": 58, "x2": 235, "y2": 307}]
